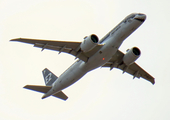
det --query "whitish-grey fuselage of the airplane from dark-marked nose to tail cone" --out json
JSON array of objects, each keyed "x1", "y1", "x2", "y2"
[{"x1": 45, "y1": 14, "x2": 146, "y2": 97}]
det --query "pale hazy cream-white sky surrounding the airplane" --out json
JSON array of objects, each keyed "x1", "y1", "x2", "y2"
[{"x1": 0, "y1": 0, "x2": 170, "y2": 120}]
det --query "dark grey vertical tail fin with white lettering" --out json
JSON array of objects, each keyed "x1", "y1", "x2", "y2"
[{"x1": 42, "y1": 68, "x2": 58, "y2": 86}]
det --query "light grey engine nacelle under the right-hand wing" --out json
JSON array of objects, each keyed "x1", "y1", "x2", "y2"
[{"x1": 123, "y1": 47, "x2": 141, "y2": 66}]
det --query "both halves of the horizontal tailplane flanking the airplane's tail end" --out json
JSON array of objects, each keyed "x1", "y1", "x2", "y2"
[{"x1": 24, "y1": 85, "x2": 68, "y2": 100}]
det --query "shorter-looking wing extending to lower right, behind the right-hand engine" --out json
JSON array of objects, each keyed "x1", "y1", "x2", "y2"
[{"x1": 102, "y1": 50, "x2": 155, "y2": 84}]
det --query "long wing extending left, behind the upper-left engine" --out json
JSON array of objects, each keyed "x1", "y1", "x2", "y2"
[{"x1": 10, "y1": 38, "x2": 103, "y2": 62}]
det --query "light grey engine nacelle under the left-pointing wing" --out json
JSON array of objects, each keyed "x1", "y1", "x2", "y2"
[{"x1": 80, "y1": 34, "x2": 99, "y2": 52}]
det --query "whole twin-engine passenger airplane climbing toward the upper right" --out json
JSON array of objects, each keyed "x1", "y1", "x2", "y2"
[{"x1": 10, "y1": 13, "x2": 155, "y2": 100}]
